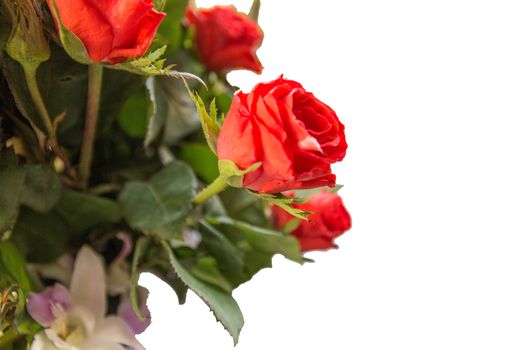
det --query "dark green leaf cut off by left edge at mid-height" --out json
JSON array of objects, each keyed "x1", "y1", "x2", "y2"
[{"x1": 0, "y1": 150, "x2": 25, "y2": 233}]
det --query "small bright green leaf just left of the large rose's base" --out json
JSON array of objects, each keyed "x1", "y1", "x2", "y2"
[{"x1": 180, "y1": 143, "x2": 219, "y2": 183}]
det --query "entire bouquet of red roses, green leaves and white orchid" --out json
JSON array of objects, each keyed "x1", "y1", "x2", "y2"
[{"x1": 0, "y1": 0, "x2": 351, "y2": 350}]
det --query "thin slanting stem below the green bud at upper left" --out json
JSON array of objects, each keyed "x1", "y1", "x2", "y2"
[{"x1": 22, "y1": 64, "x2": 76, "y2": 178}]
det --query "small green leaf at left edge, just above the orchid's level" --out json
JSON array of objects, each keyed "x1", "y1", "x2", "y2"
[{"x1": 0, "y1": 241, "x2": 31, "y2": 293}]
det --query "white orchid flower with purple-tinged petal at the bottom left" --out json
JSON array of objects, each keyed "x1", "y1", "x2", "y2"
[{"x1": 27, "y1": 246, "x2": 144, "y2": 350}]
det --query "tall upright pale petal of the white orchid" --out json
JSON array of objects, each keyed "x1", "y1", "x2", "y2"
[{"x1": 69, "y1": 246, "x2": 106, "y2": 319}]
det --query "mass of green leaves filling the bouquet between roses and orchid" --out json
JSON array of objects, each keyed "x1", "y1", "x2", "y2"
[{"x1": 0, "y1": 0, "x2": 303, "y2": 349}]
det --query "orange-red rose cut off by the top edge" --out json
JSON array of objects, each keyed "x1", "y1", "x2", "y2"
[{"x1": 47, "y1": 0, "x2": 165, "y2": 63}]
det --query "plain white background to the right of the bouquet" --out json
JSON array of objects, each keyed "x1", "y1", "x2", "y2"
[{"x1": 140, "y1": 0, "x2": 525, "y2": 350}]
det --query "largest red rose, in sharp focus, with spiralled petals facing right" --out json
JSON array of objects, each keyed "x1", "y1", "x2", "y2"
[{"x1": 217, "y1": 77, "x2": 347, "y2": 193}]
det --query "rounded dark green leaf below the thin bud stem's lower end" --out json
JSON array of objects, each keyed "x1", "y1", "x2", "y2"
[{"x1": 20, "y1": 164, "x2": 62, "y2": 213}]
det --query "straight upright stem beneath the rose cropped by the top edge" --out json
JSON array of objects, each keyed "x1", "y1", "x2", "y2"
[{"x1": 79, "y1": 64, "x2": 104, "y2": 188}]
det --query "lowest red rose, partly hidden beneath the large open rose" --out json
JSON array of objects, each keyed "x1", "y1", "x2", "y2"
[{"x1": 272, "y1": 190, "x2": 352, "y2": 251}]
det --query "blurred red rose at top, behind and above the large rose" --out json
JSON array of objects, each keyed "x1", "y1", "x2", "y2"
[{"x1": 186, "y1": 6, "x2": 263, "y2": 73}]
